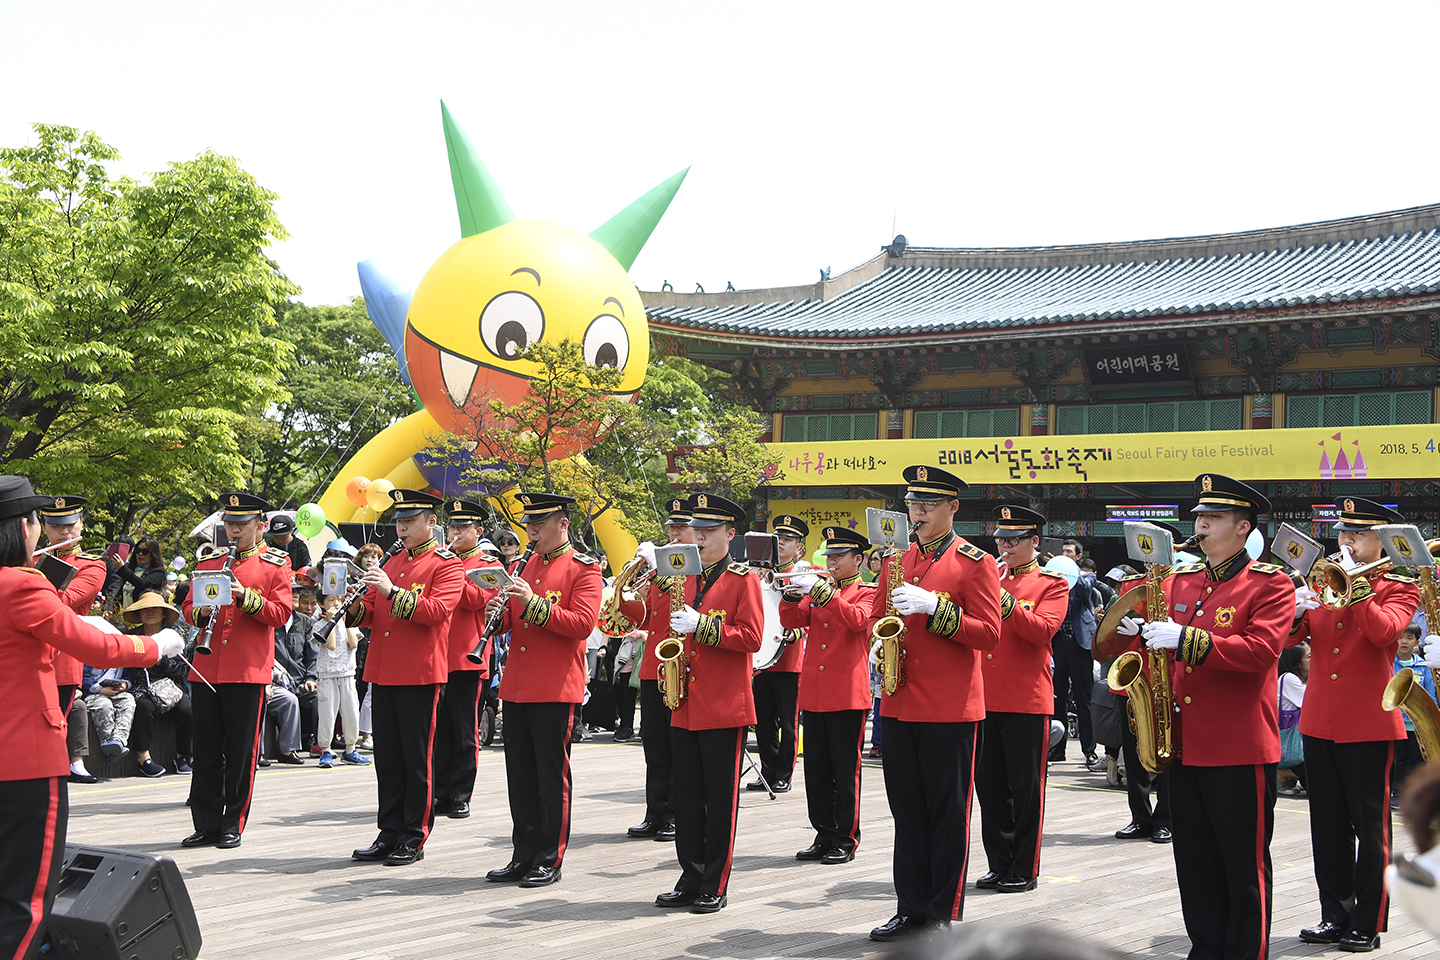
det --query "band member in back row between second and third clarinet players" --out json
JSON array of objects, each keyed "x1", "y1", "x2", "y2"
[{"x1": 435, "y1": 499, "x2": 500, "y2": 820}]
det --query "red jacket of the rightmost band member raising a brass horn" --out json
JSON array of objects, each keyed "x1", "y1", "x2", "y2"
[{"x1": 1290, "y1": 573, "x2": 1416, "y2": 743}]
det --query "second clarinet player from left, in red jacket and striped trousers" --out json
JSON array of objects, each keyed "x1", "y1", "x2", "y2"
[{"x1": 346, "y1": 488, "x2": 465, "y2": 866}]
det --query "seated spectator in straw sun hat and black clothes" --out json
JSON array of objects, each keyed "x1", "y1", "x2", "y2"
[{"x1": 122, "y1": 593, "x2": 194, "y2": 777}]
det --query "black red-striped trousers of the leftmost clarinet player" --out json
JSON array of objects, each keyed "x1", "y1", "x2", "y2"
[{"x1": 190, "y1": 684, "x2": 265, "y2": 833}]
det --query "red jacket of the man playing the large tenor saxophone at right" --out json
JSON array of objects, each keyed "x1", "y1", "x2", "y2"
[{"x1": 1165, "y1": 550, "x2": 1309, "y2": 767}]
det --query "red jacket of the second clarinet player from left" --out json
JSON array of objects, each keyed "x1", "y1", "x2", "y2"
[{"x1": 347, "y1": 538, "x2": 465, "y2": 687}]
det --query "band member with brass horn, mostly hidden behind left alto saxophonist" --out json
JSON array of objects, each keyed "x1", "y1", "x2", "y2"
[{"x1": 621, "y1": 498, "x2": 696, "y2": 843}]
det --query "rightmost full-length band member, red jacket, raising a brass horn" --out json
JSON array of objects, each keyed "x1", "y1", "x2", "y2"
[{"x1": 1290, "y1": 497, "x2": 1416, "y2": 953}]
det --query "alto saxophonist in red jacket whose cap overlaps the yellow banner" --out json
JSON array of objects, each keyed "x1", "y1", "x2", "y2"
[{"x1": 870, "y1": 466, "x2": 999, "y2": 940}]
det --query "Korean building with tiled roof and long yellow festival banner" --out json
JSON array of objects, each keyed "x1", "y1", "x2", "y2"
[{"x1": 641, "y1": 204, "x2": 1440, "y2": 563}]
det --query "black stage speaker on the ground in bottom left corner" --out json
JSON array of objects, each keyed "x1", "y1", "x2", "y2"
[{"x1": 46, "y1": 843, "x2": 200, "y2": 960}]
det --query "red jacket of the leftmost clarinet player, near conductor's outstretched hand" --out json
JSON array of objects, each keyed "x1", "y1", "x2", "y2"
[{"x1": 180, "y1": 544, "x2": 291, "y2": 684}]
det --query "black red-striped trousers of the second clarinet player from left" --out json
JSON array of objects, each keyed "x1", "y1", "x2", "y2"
[{"x1": 370, "y1": 681, "x2": 442, "y2": 846}]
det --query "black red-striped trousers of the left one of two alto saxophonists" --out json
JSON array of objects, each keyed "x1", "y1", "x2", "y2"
[{"x1": 670, "y1": 727, "x2": 746, "y2": 897}]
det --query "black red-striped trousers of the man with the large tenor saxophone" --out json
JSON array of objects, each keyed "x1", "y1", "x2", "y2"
[{"x1": 1166, "y1": 759, "x2": 1277, "y2": 960}]
